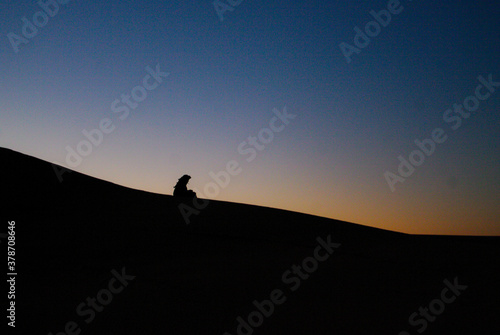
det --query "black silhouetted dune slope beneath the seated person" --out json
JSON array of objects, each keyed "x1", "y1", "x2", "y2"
[{"x1": 0, "y1": 149, "x2": 500, "y2": 335}]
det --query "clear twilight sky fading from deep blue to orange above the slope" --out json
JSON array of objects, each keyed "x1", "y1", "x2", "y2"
[{"x1": 0, "y1": 0, "x2": 500, "y2": 235}]
